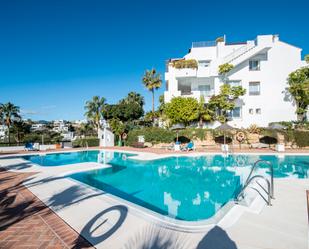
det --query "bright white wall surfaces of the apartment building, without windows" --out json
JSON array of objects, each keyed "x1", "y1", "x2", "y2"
[{"x1": 164, "y1": 35, "x2": 304, "y2": 127}]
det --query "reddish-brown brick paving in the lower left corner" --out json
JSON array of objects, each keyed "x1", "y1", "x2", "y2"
[{"x1": 0, "y1": 169, "x2": 93, "y2": 249}]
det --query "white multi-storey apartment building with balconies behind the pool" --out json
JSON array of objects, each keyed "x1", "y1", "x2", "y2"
[{"x1": 164, "y1": 35, "x2": 306, "y2": 128}]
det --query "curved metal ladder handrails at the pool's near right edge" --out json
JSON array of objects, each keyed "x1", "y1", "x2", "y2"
[{"x1": 235, "y1": 160, "x2": 274, "y2": 206}]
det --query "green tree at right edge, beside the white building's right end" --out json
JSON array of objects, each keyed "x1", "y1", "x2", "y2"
[{"x1": 287, "y1": 66, "x2": 309, "y2": 121}]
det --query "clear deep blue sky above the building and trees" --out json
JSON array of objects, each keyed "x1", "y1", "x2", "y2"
[{"x1": 0, "y1": 0, "x2": 309, "y2": 120}]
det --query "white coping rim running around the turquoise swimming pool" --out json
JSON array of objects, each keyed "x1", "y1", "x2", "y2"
[{"x1": 0, "y1": 149, "x2": 298, "y2": 232}]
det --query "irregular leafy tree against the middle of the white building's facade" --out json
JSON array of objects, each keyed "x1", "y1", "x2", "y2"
[{"x1": 208, "y1": 84, "x2": 246, "y2": 123}]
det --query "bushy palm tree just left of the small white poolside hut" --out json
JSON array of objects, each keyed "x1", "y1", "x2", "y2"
[{"x1": 85, "y1": 96, "x2": 106, "y2": 137}]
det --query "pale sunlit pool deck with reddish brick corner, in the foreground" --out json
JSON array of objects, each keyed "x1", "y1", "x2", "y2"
[{"x1": 0, "y1": 148, "x2": 309, "y2": 249}]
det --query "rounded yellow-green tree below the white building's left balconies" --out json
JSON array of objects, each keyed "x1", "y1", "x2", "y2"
[{"x1": 164, "y1": 97, "x2": 199, "y2": 126}]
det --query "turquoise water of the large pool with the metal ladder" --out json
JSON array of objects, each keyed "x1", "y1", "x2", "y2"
[{"x1": 65, "y1": 152, "x2": 309, "y2": 221}]
